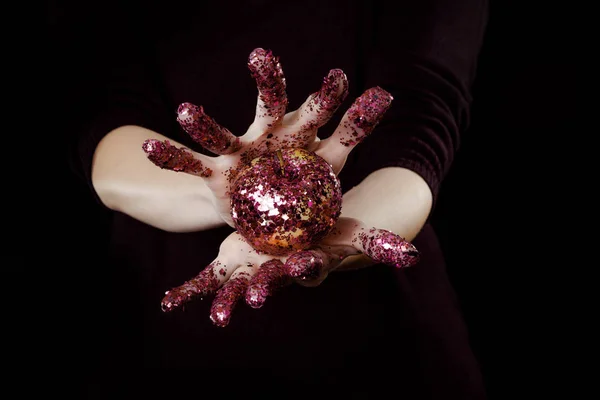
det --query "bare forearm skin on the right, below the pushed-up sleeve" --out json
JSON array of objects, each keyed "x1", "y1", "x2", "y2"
[{"x1": 338, "y1": 167, "x2": 433, "y2": 269}]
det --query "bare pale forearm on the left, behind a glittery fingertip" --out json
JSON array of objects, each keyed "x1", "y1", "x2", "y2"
[{"x1": 92, "y1": 126, "x2": 224, "y2": 232}]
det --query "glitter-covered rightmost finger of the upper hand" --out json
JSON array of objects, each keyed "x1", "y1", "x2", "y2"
[{"x1": 341, "y1": 87, "x2": 394, "y2": 146}]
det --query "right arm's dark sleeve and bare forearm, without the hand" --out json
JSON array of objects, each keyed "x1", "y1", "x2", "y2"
[{"x1": 338, "y1": 0, "x2": 488, "y2": 269}]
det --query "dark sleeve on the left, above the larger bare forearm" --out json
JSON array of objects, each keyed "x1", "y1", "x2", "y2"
[{"x1": 70, "y1": 1, "x2": 173, "y2": 204}]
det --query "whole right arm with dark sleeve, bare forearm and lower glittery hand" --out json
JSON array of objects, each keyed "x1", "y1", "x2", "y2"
[{"x1": 146, "y1": 0, "x2": 487, "y2": 326}]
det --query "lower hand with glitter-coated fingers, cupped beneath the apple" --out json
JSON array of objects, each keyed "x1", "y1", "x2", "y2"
[{"x1": 162, "y1": 218, "x2": 419, "y2": 327}]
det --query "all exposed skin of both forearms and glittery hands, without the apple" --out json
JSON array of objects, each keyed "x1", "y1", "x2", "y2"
[{"x1": 92, "y1": 49, "x2": 432, "y2": 326}]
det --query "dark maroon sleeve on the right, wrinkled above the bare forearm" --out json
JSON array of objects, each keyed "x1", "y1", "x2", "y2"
[{"x1": 355, "y1": 0, "x2": 488, "y2": 203}]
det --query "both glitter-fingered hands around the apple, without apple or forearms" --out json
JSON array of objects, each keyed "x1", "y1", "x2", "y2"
[{"x1": 143, "y1": 49, "x2": 418, "y2": 326}]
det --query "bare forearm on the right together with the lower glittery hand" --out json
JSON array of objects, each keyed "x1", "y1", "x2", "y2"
[{"x1": 156, "y1": 168, "x2": 432, "y2": 326}]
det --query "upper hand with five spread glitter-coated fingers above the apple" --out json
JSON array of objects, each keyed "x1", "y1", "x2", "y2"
[{"x1": 143, "y1": 49, "x2": 392, "y2": 226}]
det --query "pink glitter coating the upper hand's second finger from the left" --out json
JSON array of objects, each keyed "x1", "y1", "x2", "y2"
[{"x1": 177, "y1": 103, "x2": 241, "y2": 154}]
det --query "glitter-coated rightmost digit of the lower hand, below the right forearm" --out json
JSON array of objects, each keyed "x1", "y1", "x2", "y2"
[{"x1": 358, "y1": 228, "x2": 420, "y2": 268}]
